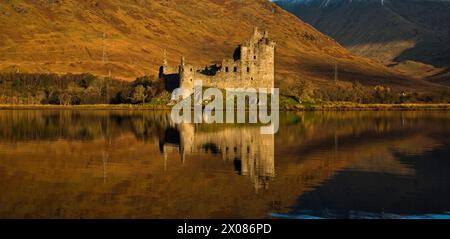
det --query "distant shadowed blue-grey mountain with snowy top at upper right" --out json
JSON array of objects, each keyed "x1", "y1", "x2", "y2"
[{"x1": 277, "y1": 0, "x2": 450, "y2": 80}]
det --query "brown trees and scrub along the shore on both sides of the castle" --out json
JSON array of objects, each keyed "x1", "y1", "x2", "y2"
[{"x1": 0, "y1": 73, "x2": 450, "y2": 110}]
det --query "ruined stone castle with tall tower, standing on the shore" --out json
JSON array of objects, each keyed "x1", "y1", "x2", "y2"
[{"x1": 160, "y1": 28, "x2": 276, "y2": 90}]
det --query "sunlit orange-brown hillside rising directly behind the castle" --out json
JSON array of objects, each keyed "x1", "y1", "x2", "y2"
[{"x1": 0, "y1": 0, "x2": 442, "y2": 89}]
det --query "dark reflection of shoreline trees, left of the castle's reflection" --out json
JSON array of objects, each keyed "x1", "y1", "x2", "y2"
[{"x1": 0, "y1": 110, "x2": 169, "y2": 141}]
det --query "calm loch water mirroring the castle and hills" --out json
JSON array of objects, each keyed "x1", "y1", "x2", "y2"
[{"x1": 0, "y1": 110, "x2": 450, "y2": 218}]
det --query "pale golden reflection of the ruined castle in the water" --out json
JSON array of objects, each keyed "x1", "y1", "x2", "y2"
[{"x1": 160, "y1": 124, "x2": 275, "y2": 191}]
